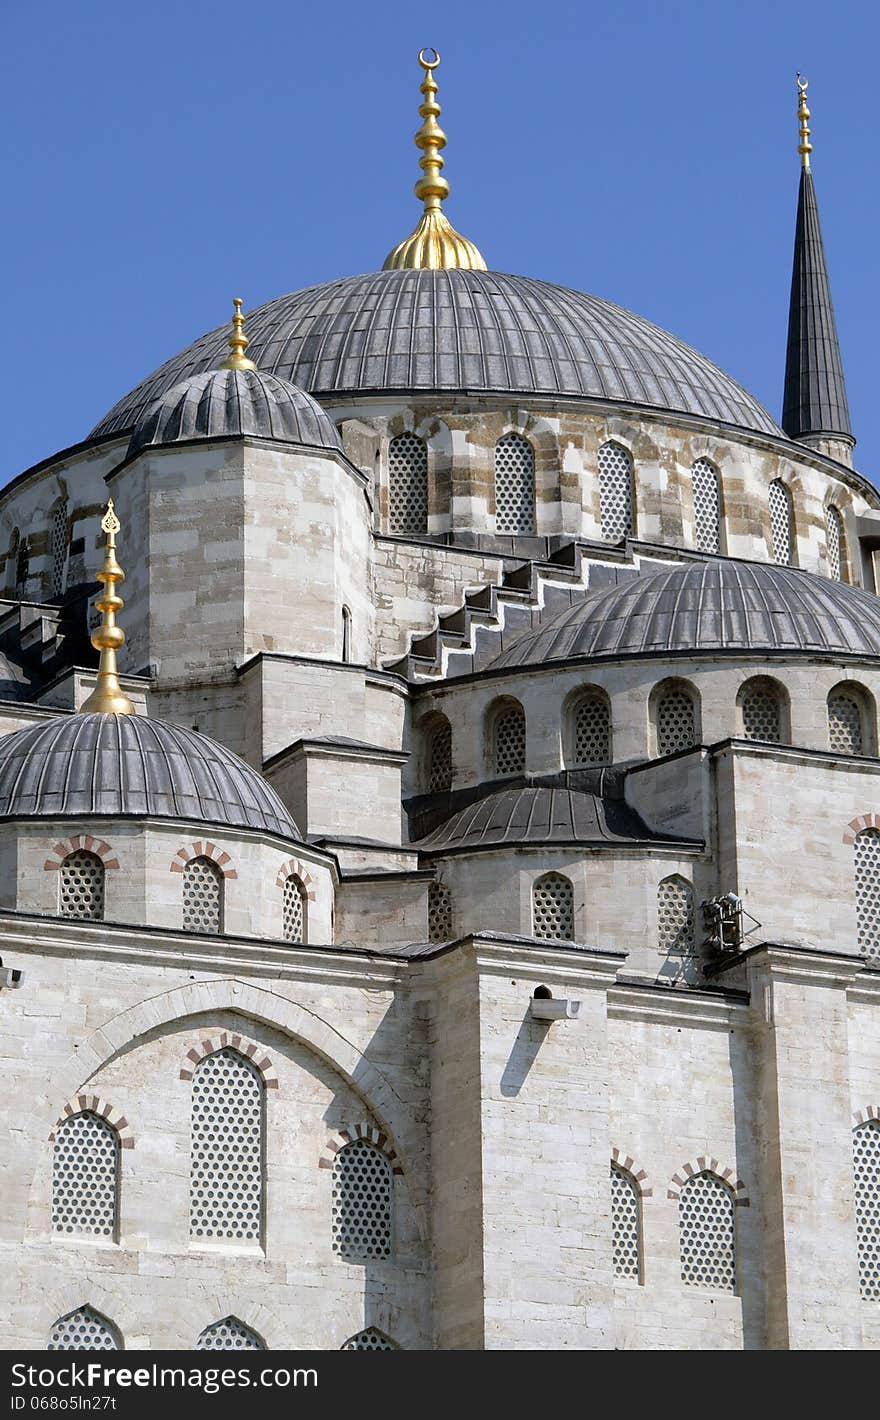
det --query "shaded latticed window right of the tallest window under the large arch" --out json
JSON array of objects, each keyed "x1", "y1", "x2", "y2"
[{"x1": 331, "y1": 1139, "x2": 393, "y2": 1262}]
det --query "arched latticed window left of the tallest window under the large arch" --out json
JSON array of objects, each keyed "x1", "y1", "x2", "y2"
[{"x1": 53, "y1": 1109, "x2": 119, "y2": 1241}]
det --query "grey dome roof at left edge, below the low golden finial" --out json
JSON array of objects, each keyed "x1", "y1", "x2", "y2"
[{"x1": 0, "y1": 714, "x2": 301, "y2": 841}]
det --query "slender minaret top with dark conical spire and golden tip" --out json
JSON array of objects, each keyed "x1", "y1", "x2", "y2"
[{"x1": 782, "y1": 75, "x2": 856, "y2": 467}]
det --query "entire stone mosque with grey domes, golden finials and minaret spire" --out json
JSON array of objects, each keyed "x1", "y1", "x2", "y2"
[{"x1": 0, "y1": 51, "x2": 880, "y2": 1350}]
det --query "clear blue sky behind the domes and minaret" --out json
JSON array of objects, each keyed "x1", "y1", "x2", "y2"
[{"x1": 0, "y1": 0, "x2": 880, "y2": 483}]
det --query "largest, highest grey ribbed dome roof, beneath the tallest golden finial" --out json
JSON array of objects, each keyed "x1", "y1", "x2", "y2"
[{"x1": 94, "y1": 271, "x2": 782, "y2": 436}]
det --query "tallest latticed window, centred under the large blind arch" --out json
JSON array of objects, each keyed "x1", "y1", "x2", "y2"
[{"x1": 190, "y1": 1049, "x2": 264, "y2": 1243}]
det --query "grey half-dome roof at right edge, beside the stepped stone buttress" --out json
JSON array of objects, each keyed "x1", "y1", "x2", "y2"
[{"x1": 485, "y1": 559, "x2": 880, "y2": 670}]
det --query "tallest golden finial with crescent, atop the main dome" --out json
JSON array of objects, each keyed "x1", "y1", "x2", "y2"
[{"x1": 382, "y1": 50, "x2": 485, "y2": 271}]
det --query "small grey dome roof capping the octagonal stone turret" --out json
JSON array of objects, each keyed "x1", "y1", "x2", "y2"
[{"x1": 128, "y1": 369, "x2": 342, "y2": 459}]
